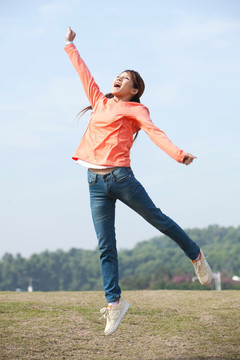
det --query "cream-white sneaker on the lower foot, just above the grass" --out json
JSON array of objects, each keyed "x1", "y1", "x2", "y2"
[{"x1": 100, "y1": 299, "x2": 129, "y2": 335}]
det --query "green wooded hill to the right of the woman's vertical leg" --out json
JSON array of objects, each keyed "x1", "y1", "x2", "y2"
[{"x1": 119, "y1": 225, "x2": 240, "y2": 289}]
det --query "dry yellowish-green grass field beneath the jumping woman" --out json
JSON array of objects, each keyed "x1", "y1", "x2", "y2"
[{"x1": 0, "y1": 290, "x2": 240, "y2": 360}]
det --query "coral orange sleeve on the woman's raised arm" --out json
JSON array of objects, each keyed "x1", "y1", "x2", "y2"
[{"x1": 64, "y1": 44, "x2": 104, "y2": 108}]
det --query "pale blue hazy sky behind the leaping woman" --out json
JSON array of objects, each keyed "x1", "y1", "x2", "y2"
[{"x1": 0, "y1": 0, "x2": 240, "y2": 257}]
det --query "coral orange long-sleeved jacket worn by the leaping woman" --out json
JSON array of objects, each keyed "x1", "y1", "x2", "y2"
[{"x1": 65, "y1": 44, "x2": 186, "y2": 167}]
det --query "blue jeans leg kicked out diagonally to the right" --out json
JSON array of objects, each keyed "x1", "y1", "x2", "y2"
[{"x1": 113, "y1": 167, "x2": 200, "y2": 260}]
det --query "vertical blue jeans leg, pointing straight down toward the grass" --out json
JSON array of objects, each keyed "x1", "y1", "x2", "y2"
[{"x1": 88, "y1": 172, "x2": 121, "y2": 303}]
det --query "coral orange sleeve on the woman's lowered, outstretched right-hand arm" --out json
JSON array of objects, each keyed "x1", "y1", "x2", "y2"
[{"x1": 137, "y1": 107, "x2": 187, "y2": 163}]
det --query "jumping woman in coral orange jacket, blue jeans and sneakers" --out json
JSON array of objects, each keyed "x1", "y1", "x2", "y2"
[{"x1": 65, "y1": 28, "x2": 212, "y2": 335}]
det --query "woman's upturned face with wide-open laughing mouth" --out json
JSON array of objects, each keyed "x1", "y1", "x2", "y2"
[{"x1": 111, "y1": 72, "x2": 138, "y2": 101}]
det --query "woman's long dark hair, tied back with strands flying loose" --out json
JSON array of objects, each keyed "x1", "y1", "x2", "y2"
[{"x1": 78, "y1": 70, "x2": 145, "y2": 141}]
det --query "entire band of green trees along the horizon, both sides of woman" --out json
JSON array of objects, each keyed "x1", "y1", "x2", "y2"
[{"x1": 0, "y1": 225, "x2": 240, "y2": 291}]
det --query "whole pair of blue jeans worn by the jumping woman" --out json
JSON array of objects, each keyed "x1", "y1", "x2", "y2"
[{"x1": 88, "y1": 167, "x2": 200, "y2": 302}]
